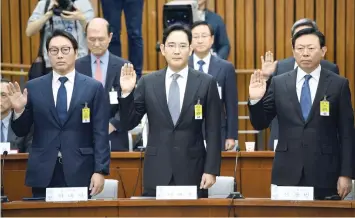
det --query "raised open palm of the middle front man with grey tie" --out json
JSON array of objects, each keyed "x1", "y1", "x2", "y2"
[{"x1": 120, "y1": 64, "x2": 137, "y2": 94}]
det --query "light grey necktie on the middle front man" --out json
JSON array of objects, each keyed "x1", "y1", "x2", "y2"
[{"x1": 168, "y1": 73, "x2": 180, "y2": 125}]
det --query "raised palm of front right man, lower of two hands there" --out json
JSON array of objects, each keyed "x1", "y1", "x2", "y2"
[{"x1": 249, "y1": 70, "x2": 266, "y2": 100}]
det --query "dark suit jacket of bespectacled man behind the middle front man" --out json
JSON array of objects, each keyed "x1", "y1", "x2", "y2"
[{"x1": 189, "y1": 55, "x2": 238, "y2": 148}]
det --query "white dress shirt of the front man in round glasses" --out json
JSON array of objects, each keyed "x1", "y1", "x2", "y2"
[{"x1": 52, "y1": 70, "x2": 75, "y2": 110}]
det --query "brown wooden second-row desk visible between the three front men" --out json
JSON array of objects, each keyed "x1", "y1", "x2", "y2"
[{"x1": 4, "y1": 151, "x2": 274, "y2": 201}]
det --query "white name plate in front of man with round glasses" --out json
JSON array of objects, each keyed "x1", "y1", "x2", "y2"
[{"x1": 46, "y1": 187, "x2": 88, "y2": 202}]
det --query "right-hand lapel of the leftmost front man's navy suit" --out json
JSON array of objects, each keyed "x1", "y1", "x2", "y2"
[{"x1": 63, "y1": 72, "x2": 86, "y2": 126}]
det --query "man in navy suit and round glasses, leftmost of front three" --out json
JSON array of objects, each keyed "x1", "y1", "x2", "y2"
[{"x1": 8, "y1": 30, "x2": 110, "y2": 197}]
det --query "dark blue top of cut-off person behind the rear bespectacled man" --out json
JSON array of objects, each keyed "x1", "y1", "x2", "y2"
[{"x1": 205, "y1": 10, "x2": 230, "y2": 60}]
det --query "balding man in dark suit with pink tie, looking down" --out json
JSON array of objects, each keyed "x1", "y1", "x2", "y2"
[{"x1": 75, "y1": 18, "x2": 128, "y2": 151}]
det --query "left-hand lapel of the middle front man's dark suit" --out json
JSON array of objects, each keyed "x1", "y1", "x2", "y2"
[{"x1": 154, "y1": 68, "x2": 174, "y2": 126}]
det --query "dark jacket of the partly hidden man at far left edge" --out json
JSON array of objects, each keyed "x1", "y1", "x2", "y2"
[{"x1": 7, "y1": 113, "x2": 33, "y2": 153}]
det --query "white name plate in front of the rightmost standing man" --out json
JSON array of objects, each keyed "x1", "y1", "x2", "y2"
[{"x1": 271, "y1": 185, "x2": 314, "y2": 201}]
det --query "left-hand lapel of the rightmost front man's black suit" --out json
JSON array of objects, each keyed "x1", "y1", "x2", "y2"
[{"x1": 286, "y1": 68, "x2": 304, "y2": 122}]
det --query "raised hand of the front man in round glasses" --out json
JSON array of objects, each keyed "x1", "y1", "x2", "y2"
[{"x1": 7, "y1": 82, "x2": 27, "y2": 113}]
